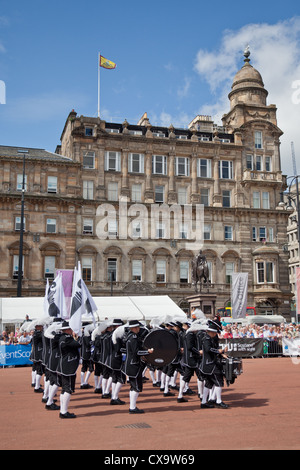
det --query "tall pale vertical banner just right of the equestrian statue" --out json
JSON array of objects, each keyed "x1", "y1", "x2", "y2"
[{"x1": 231, "y1": 273, "x2": 248, "y2": 318}]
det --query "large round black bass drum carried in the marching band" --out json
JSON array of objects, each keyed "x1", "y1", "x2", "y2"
[{"x1": 144, "y1": 330, "x2": 178, "y2": 368}]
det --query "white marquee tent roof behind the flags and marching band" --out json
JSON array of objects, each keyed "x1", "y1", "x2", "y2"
[{"x1": 0, "y1": 295, "x2": 186, "y2": 329}]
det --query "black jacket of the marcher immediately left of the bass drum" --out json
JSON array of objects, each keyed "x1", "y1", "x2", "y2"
[{"x1": 124, "y1": 332, "x2": 149, "y2": 377}]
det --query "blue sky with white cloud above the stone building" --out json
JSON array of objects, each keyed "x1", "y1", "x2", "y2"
[{"x1": 0, "y1": 0, "x2": 300, "y2": 175}]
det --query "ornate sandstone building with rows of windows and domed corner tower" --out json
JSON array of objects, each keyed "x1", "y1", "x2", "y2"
[{"x1": 0, "y1": 54, "x2": 291, "y2": 316}]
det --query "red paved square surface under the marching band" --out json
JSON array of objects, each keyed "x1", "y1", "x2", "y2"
[{"x1": 0, "y1": 357, "x2": 300, "y2": 455}]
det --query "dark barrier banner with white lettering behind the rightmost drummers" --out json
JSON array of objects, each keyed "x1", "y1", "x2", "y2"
[{"x1": 220, "y1": 338, "x2": 264, "y2": 358}]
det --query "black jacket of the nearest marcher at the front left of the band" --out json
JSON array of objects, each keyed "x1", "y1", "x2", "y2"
[{"x1": 57, "y1": 333, "x2": 80, "y2": 376}]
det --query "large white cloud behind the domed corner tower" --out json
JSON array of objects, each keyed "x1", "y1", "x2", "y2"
[{"x1": 195, "y1": 17, "x2": 300, "y2": 175}]
